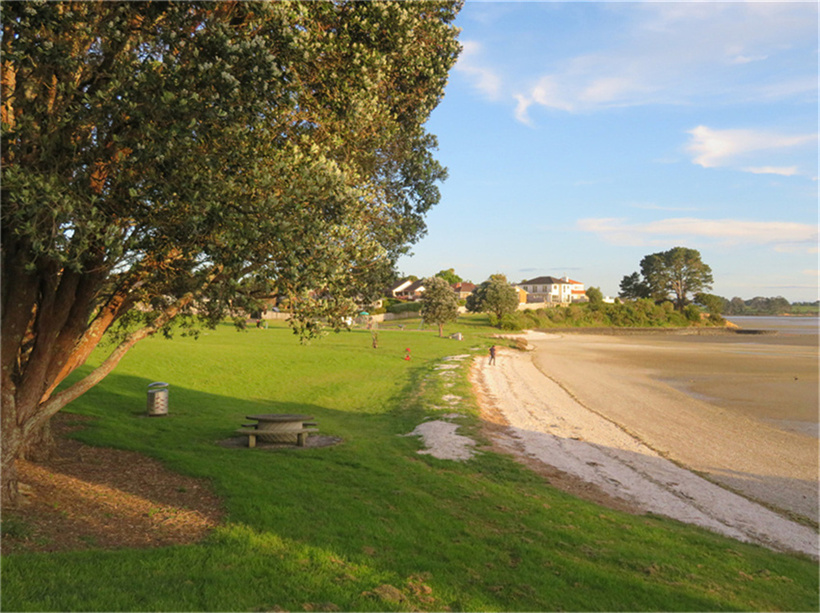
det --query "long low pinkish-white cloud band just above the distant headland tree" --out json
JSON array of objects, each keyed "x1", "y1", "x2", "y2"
[{"x1": 577, "y1": 217, "x2": 818, "y2": 252}]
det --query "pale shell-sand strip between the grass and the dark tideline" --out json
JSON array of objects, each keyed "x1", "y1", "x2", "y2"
[{"x1": 475, "y1": 335, "x2": 818, "y2": 557}]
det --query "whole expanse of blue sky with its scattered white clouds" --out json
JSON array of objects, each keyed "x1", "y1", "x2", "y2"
[{"x1": 398, "y1": 1, "x2": 818, "y2": 301}]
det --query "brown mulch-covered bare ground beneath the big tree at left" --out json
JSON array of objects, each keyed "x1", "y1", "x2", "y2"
[{"x1": 2, "y1": 414, "x2": 224, "y2": 553}]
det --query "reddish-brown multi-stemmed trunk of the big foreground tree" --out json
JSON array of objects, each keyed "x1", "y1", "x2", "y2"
[{"x1": 0, "y1": 253, "x2": 211, "y2": 507}]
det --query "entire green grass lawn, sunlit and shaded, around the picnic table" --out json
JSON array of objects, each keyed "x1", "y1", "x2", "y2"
[{"x1": 0, "y1": 317, "x2": 819, "y2": 611}]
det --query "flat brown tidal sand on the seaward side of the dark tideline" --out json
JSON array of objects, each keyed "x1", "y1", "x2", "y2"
[{"x1": 533, "y1": 334, "x2": 818, "y2": 522}]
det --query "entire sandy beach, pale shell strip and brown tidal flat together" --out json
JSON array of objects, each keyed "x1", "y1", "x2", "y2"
[{"x1": 473, "y1": 332, "x2": 818, "y2": 557}]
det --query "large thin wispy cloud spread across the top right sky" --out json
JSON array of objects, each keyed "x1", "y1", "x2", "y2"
[{"x1": 513, "y1": 2, "x2": 817, "y2": 125}]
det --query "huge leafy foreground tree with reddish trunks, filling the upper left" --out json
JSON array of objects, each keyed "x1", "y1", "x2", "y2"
[{"x1": 0, "y1": 0, "x2": 460, "y2": 503}]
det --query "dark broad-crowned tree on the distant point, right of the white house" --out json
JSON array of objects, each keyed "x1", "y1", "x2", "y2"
[{"x1": 621, "y1": 247, "x2": 713, "y2": 311}]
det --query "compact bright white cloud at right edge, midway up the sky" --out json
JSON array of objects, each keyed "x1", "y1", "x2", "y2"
[{"x1": 686, "y1": 126, "x2": 817, "y2": 171}]
